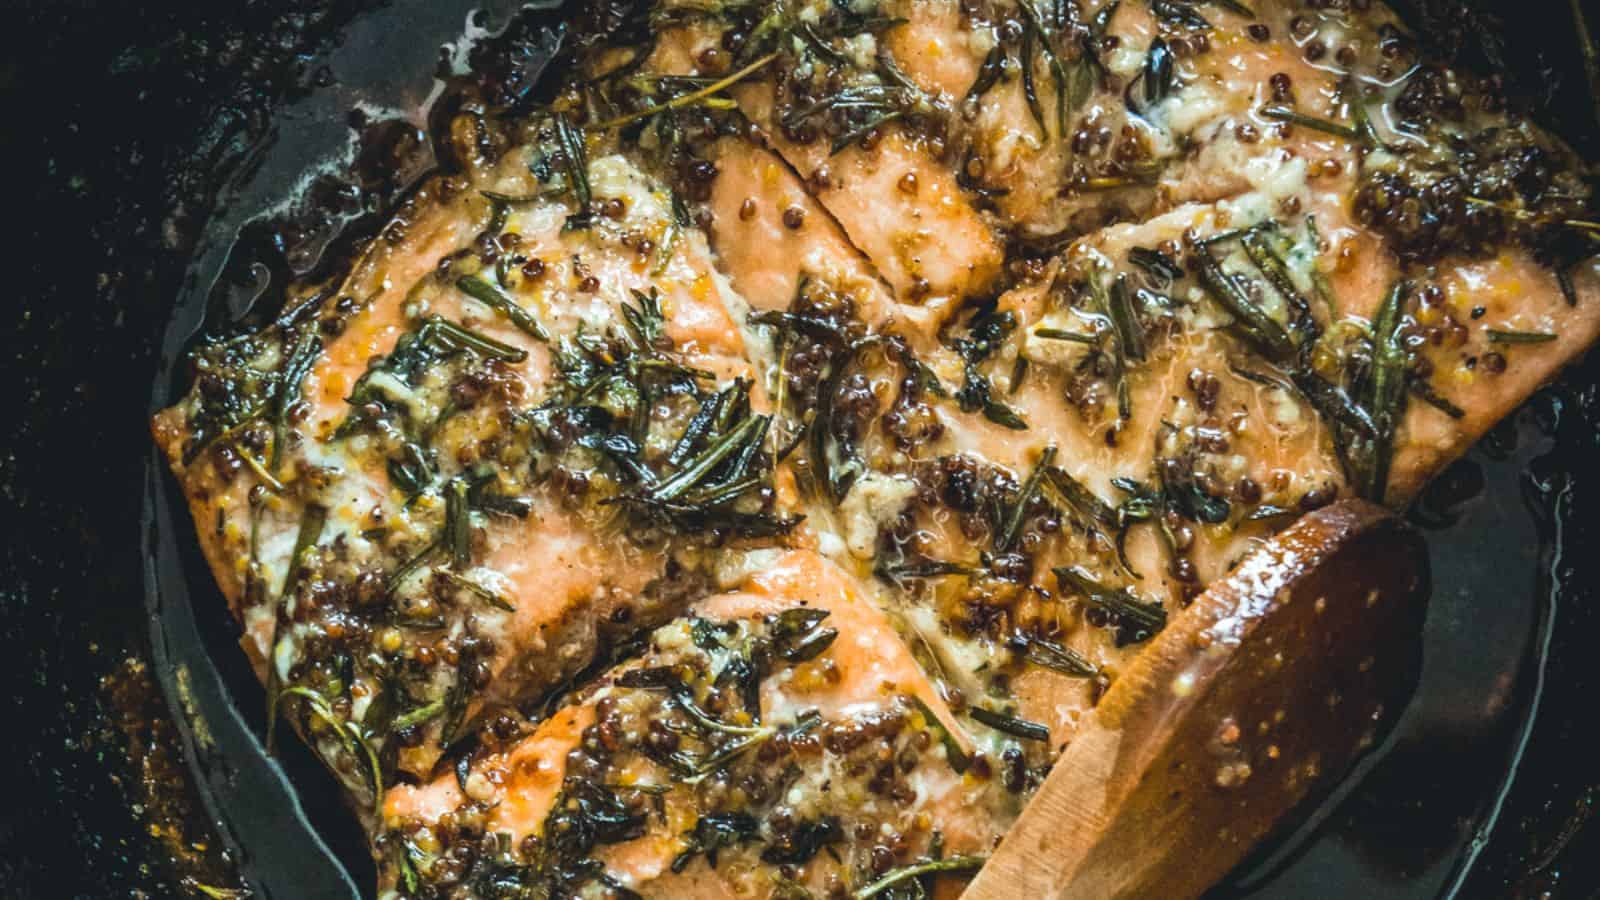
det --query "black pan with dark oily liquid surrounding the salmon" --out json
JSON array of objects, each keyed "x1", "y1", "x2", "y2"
[{"x1": 0, "y1": 0, "x2": 1600, "y2": 900}]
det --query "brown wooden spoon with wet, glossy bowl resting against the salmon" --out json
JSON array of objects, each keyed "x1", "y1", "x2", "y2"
[{"x1": 963, "y1": 501, "x2": 1429, "y2": 900}]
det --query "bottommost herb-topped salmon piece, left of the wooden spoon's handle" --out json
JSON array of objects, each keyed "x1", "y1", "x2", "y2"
[{"x1": 384, "y1": 551, "x2": 998, "y2": 897}]
